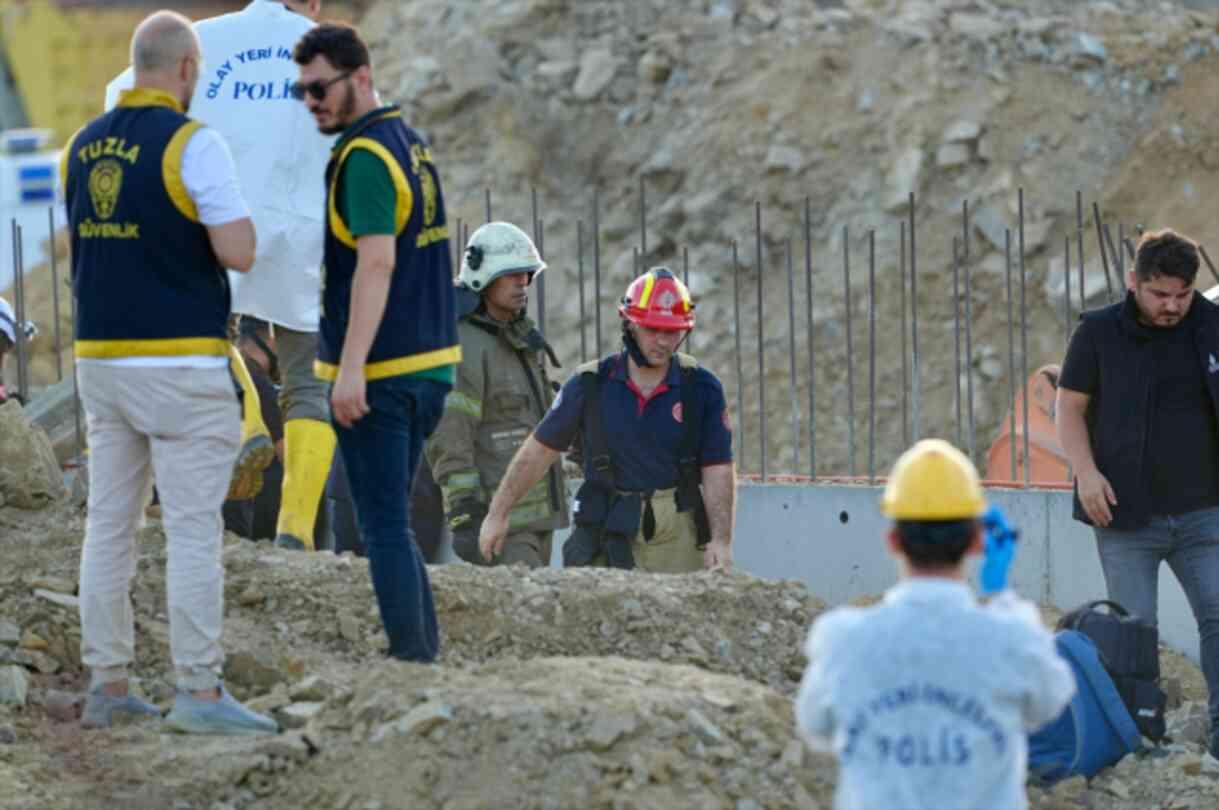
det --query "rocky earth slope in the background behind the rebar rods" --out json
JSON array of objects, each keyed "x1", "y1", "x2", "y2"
[{"x1": 363, "y1": 0, "x2": 1219, "y2": 473}]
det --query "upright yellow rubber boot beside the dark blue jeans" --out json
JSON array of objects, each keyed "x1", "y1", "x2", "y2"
[{"x1": 275, "y1": 420, "x2": 336, "y2": 551}]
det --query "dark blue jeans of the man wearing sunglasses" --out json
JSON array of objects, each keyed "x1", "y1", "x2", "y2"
[{"x1": 334, "y1": 377, "x2": 450, "y2": 662}]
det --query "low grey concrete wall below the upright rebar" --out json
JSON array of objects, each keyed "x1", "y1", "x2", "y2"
[{"x1": 536, "y1": 483, "x2": 1198, "y2": 661}]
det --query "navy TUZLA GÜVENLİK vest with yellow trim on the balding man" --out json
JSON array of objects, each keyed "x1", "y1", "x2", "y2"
[{"x1": 60, "y1": 88, "x2": 230, "y2": 357}]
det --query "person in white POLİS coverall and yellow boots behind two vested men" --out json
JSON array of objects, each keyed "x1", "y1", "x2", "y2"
[{"x1": 107, "y1": 0, "x2": 335, "y2": 549}]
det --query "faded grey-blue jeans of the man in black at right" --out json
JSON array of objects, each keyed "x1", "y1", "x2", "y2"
[{"x1": 1095, "y1": 506, "x2": 1219, "y2": 723}]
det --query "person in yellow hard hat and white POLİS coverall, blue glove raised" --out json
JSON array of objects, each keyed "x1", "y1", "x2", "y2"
[{"x1": 796, "y1": 439, "x2": 1075, "y2": 810}]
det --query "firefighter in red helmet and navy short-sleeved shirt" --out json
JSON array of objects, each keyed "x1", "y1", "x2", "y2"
[{"x1": 479, "y1": 267, "x2": 736, "y2": 573}]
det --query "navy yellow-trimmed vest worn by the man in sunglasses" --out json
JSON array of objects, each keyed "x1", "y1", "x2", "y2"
[{"x1": 313, "y1": 107, "x2": 461, "y2": 381}]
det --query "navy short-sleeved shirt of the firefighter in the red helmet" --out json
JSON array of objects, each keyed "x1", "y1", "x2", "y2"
[{"x1": 534, "y1": 351, "x2": 733, "y2": 492}]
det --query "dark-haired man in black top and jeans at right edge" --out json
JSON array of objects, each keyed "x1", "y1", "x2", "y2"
[{"x1": 1058, "y1": 231, "x2": 1219, "y2": 755}]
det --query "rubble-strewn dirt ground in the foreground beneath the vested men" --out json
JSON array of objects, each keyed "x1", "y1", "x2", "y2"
[{"x1": 0, "y1": 501, "x2": 1219, "y2": 810}]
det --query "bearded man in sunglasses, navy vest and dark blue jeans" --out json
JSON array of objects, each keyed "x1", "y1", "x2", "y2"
[{"x1": 293, "y1": 24, "x2": 461, "y2": 661}]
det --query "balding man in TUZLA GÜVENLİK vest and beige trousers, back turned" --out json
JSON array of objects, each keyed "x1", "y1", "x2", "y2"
[{"x1": 61, "y1": 11, "x2": 277, "y2": 734}]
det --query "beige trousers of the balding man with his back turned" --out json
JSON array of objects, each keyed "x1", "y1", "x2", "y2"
[{"x1": 77, "y1": 362, "x2": 241, "y2": 690}]
